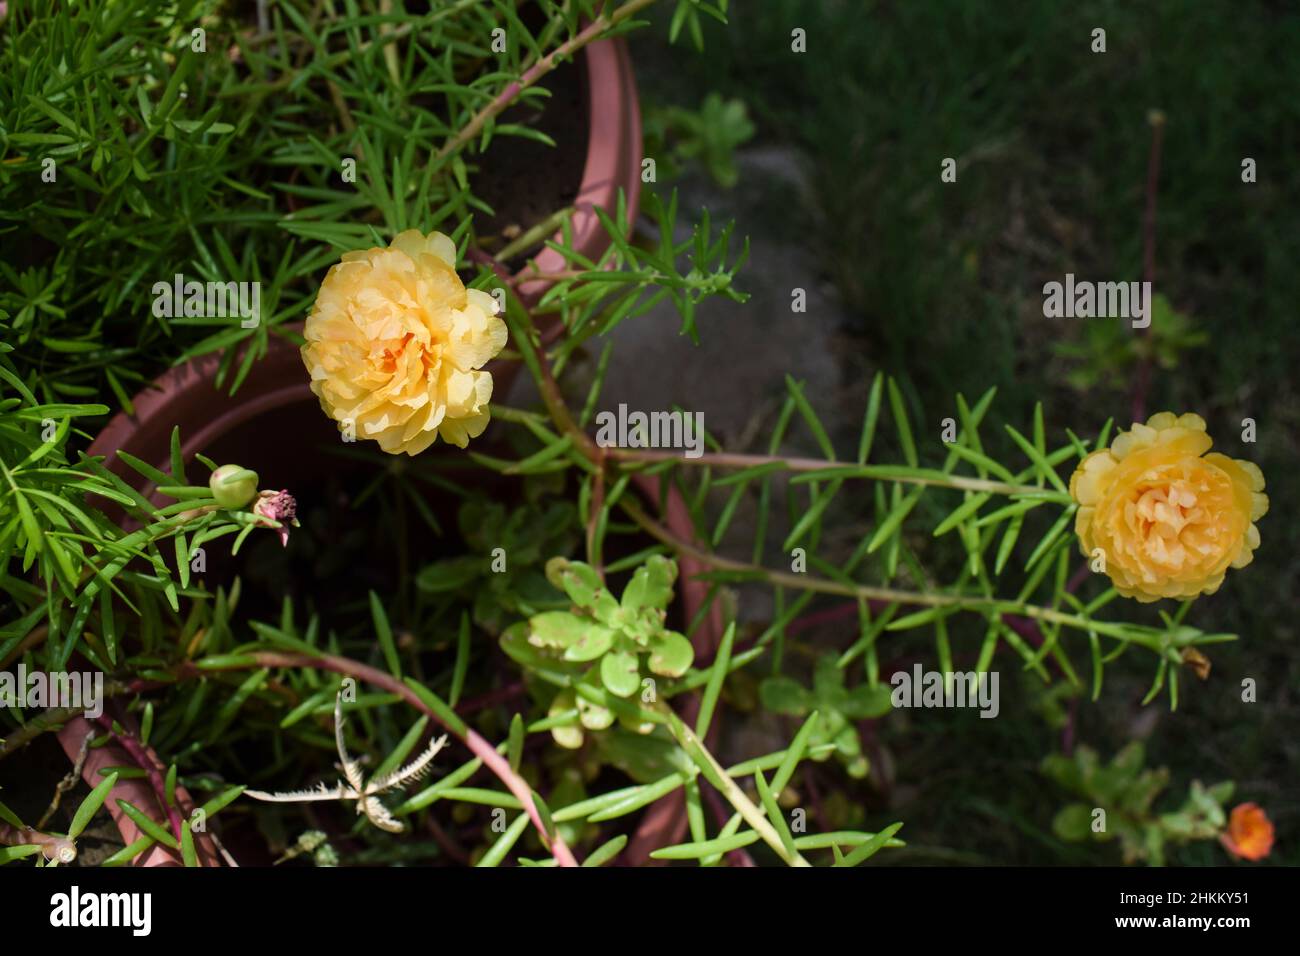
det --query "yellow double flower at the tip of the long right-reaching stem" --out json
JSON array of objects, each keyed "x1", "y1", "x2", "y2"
[{"x1": 1070, "y1": 411, "x2": 1269, "y2": 602}]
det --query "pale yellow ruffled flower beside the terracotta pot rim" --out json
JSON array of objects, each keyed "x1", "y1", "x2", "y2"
[{"x1": 302, "y1": 229, "x2": 506, "y2": 455}]
